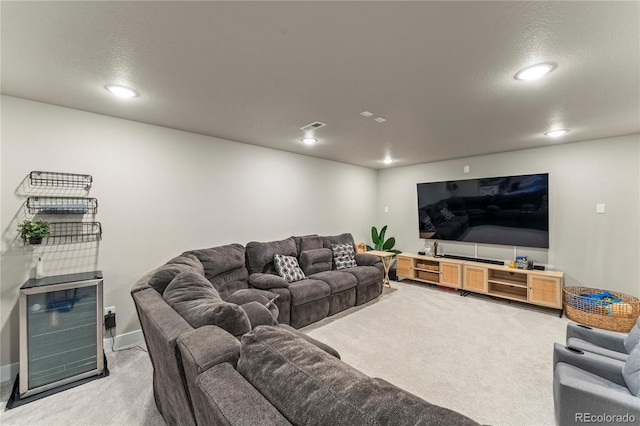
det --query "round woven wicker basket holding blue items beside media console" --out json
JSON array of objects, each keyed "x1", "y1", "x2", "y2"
[{"x1": 562, "y1": 287, "x2": 640, "y2": 333}]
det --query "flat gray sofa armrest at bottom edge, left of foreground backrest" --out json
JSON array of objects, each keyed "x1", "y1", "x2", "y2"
[{"x1": 192, "y1": 364, "x2": 291, "y2": 426}]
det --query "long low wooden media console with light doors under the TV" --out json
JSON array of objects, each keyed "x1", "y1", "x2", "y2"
[{"x1": 396, "y1": 253, "x2": 564, "y2": 315}]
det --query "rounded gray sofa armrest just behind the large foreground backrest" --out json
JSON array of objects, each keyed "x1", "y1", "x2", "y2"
[{"x1": 178, "y1": 325, "x2": 240, "y2": 383}]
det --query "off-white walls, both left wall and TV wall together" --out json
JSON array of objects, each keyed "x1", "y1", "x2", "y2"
[{"x1": 0, "y1": 96, "x2": 640, "y2": 372}]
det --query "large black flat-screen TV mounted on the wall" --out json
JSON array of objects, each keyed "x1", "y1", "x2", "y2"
[{"x1": 418, "y1": 173, "x2": 549, "y2": 248}]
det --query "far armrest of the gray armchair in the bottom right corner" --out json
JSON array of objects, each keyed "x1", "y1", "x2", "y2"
[{"x1": 553, "y1": 343, "x2": 627, "y2": 387}]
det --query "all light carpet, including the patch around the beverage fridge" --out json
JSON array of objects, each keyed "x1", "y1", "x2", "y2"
[{"x1": 0, "y1": 281, "x2": 567, "y2": 426}]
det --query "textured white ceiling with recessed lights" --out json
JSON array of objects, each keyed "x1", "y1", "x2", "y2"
[{"x1": 0, "y1": 1, "x2": 640, "y2": 168}]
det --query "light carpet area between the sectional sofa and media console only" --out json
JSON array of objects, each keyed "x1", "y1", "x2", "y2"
[{"x1": 303, "y1": 281, "x2": 568, "y2": 426}]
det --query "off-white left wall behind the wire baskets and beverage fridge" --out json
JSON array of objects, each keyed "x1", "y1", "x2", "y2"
[{"x1": 0, "y1": 96, "x2": 377, "y2": 366}]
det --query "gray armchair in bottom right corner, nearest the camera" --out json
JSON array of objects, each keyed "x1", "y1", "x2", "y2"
[{"x1": 553, "y1": 343, "x2": 640, "y2": 426}]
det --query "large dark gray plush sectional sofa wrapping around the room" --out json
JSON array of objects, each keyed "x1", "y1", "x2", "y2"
[{"x1": 131, "y1": 234, "x2": 475, "y2": 425}]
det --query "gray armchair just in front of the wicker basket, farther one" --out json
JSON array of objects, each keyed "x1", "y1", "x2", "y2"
[{"x1": 567, "y1": 318, "x2": 640, "y2": 361}]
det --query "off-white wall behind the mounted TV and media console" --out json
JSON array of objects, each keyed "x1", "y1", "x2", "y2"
[{"x1": 377, "y1": 134, "x2": 640, "y2": 296}]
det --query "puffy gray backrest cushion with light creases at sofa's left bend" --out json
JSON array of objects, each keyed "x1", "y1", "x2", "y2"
[{"x1": 163, "y1": 272, "x2": 251, "y2": 336}]
